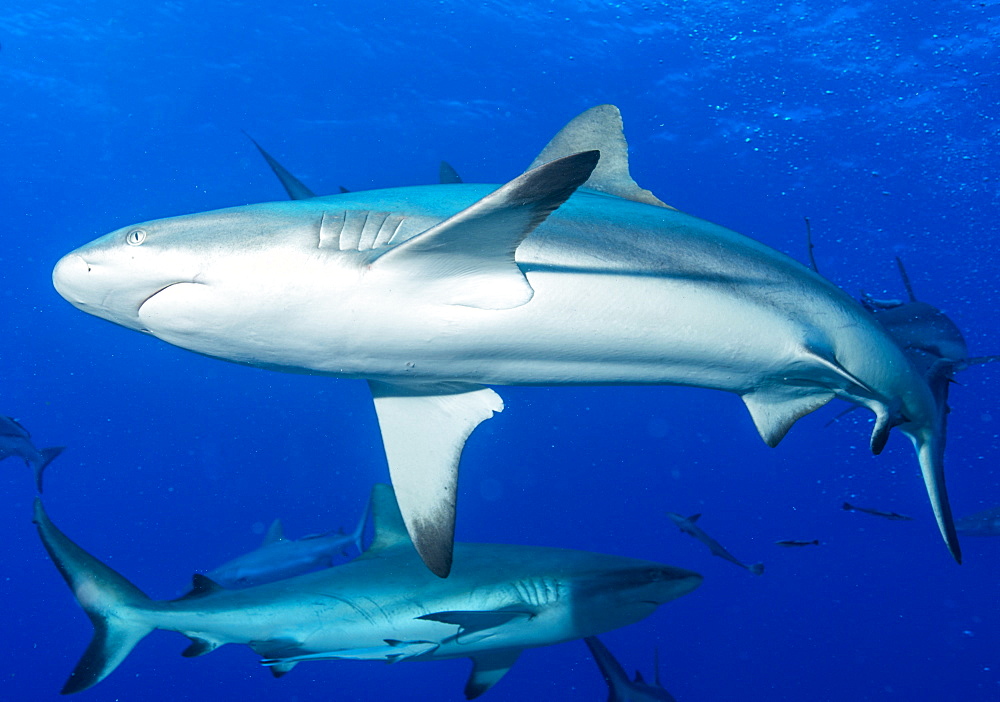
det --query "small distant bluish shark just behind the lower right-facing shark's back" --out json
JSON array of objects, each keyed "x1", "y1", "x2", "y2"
[{"x1": 207, "y1": 498, "x2": 368, "y2": 588}]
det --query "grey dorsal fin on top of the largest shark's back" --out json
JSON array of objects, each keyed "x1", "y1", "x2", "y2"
[{"x1": 528, "y1": 105, "x2": 674, "y2": 210}]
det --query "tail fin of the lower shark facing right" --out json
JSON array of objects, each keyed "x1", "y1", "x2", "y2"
[{"x1": 34, "y1": 500, "x2": 153, "y2": 695}]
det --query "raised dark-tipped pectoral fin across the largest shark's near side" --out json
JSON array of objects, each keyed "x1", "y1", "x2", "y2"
[{"x1": 371, "y1": 151, "x2": 600, "y2": 310}]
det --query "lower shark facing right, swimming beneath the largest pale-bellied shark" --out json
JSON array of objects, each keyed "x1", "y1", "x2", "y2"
[{"x1": 34, "y1": 484, "x2": 702, "y2": 699}]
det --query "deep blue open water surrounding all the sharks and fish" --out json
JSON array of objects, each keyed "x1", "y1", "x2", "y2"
[{"x1": 0, "y1": 0, "x2": 1000, "y2": 702}]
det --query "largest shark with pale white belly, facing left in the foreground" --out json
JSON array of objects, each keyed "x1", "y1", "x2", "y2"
[{"x1": 52, "y1": 105, "x2": 961, "y2": 577}]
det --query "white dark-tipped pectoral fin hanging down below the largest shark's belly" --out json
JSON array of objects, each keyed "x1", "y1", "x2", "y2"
[{"x1": 368, "y1": 381, "x2": 503, "y2": 578}]
